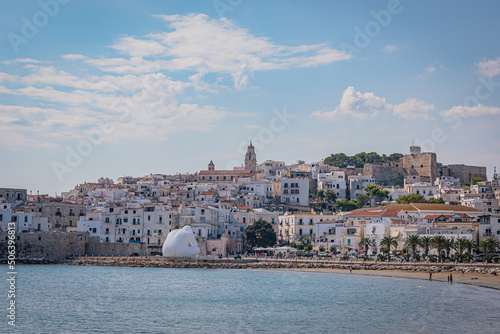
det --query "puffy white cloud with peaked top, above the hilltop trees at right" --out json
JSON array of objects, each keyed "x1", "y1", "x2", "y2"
[{"x1": 311, "y1": 86, "x2": 434, "y2": 120}]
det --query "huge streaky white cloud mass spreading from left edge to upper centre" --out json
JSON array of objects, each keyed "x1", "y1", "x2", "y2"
[{"x1": 0, "y1": 14, "x2": 349, "y2": 148}]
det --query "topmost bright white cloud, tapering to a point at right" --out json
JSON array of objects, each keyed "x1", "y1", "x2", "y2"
[{"x1": 87, "y1": 14, "x2": 351, "y2": 89}]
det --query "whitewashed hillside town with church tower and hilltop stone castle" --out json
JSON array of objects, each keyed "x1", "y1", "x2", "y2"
[{"x1": 0, "y1": 143, "x2": 500, "y2": 261}]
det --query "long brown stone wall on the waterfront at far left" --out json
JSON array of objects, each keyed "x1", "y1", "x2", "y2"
[{"x1": 0, "y1": 232, "x2": 89, "y2": 261}]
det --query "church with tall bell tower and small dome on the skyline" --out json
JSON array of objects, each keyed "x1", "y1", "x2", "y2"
[{"x1": 198, "y1": 142, "x2": 257, "y2": 183}]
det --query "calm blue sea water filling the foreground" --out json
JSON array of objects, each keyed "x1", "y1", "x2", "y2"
[{"x1": 0, "y1": 265, "x2": 500, "y2": 334}]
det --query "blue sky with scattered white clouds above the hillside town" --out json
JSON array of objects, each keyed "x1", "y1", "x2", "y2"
[{"x1": 0, "y1": 0, "x2": 500, "y2": 195}]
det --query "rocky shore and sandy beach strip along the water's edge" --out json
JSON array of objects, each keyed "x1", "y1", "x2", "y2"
[{"x1": 55, "y1": 257, "x2": 500, "y2": 290}]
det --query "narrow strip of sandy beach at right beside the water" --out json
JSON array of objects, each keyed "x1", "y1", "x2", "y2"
[{"x1": 273, "y1": 268, "x2": 500, "y2": 290}]
